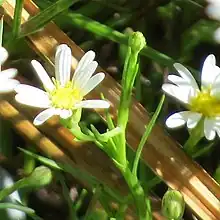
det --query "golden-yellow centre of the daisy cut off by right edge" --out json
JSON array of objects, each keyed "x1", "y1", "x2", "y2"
[{"x1": 190, "y1": 89, "x2": 220, "y2": 117}]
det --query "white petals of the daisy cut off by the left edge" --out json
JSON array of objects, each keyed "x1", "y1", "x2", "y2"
[{"x1": 0, "y1": 47, "x2": 19, "y2": 93}]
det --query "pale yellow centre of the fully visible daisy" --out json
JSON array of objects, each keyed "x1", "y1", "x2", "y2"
[{"x1": 48, "y1": 79, "x2": 83, "y2": 109}]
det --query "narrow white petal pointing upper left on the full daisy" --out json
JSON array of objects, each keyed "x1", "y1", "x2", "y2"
[{"x1": 31, "y1": 60, "x2": 55, "y2": 91}]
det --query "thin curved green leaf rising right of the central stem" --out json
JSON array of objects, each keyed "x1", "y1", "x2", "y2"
[{"x1": 132, "y1": 95, "x2": 165, "y2": 176}]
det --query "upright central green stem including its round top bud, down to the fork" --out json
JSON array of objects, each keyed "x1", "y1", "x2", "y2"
[{"x1": 116, "y1": 32, "x2": 146, "y2": 167}]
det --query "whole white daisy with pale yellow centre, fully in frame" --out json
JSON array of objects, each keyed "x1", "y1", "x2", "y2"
[{"x1": 15, "y1": 44, "x2": 110, "y2": 125}]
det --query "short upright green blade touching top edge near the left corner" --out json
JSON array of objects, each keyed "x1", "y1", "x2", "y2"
[{"x1": 12, "y1": 0, "x2": 24, "y2": 38}]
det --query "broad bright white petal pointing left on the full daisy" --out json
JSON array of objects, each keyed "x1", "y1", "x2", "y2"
[{"x1": 15, "y1": 85, "x2": 50, "y2": 108}]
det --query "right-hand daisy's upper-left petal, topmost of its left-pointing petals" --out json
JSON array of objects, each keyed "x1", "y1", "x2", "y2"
[{"x1": 173, "y1": 63, "x2": 199, "y2": 89}]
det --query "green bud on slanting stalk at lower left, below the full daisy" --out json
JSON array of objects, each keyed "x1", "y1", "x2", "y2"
[{"x1": 23, "y1": 166, "x2": 53, "y2": 188}]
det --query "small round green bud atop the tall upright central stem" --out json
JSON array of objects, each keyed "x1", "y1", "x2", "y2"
[{"x1": 128, "y1": 31, "x2": 146, "y2": 53}]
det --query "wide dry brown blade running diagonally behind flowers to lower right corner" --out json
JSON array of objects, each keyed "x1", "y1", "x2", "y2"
[{"x1": 3, "y1": 0, "x2": 220, "y2": 220}]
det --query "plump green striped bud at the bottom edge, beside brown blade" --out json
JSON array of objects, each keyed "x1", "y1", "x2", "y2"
[{"x1": 162, "y1": 190, "x2": 185, "y2": 220}]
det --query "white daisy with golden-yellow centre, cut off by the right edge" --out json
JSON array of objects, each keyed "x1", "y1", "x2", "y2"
[{"x1": 162, "y1": 55, "x2": 220, "y2": 140}]
